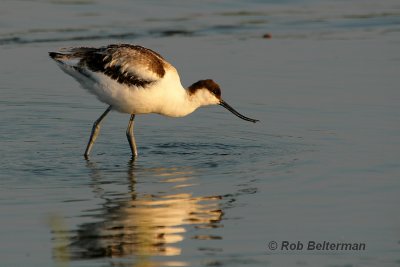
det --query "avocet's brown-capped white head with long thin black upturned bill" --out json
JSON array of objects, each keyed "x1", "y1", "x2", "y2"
[{"x1": 188, "y1": 79, "x2": 258, "y2": 122}]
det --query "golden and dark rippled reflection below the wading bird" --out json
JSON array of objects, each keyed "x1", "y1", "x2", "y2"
[{"x1": 49, "y1": 161, "x2": 223, "y2": 266}]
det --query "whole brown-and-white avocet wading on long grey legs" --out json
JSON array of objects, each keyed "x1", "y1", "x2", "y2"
[{"x1": 49, "y1": 44, "x2": 257, "y2": 157}]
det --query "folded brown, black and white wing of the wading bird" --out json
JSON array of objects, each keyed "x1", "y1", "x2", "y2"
[{"x1": 53, "y1": 44, "x2": 168, "y2": 87}]
